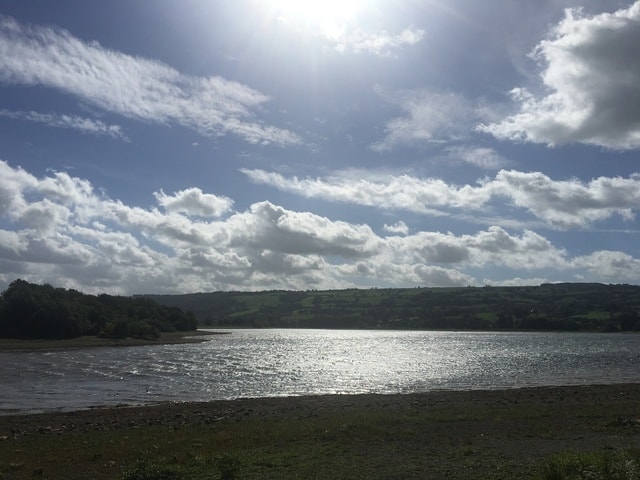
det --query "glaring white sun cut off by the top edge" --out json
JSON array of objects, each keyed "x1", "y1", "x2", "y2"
[{"x1": 265, "y1": 0, "x2": 365, "y2": 24}]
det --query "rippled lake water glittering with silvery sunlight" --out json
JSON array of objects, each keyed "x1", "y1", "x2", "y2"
[{"x1": 0, "y1": 330, "x2": 640, "y2": 414}]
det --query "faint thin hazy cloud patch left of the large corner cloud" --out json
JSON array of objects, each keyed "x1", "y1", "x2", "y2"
[{"x1": 371, "y1": 87, "x2": 485, "y2": 152}]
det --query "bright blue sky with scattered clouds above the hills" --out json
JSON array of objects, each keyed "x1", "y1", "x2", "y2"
[{"x1": 0, "y1": 0, "x2": 640, "y2": 295}]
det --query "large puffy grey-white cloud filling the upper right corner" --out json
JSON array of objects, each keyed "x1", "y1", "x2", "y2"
[{"x1": 480, "y1": 2, "x2": 640, "y2": 150}]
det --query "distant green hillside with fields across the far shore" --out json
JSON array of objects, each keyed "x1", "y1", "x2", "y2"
[{"x1": 150, "y1": 283, "x2": 640, "y2": 331}]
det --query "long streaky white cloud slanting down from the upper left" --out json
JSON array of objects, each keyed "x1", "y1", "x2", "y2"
[{"x1": 0, "y1": 16, "x2": 301, "y2": 145}]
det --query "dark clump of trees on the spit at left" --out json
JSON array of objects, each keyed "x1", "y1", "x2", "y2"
[{"x1": 0, "y1": 279, "x2": 197, "y2": 339}]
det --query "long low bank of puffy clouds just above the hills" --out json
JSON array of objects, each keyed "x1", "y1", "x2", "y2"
[{"x1": 0, "y1": 161, "x2": 640, "y2": 293}]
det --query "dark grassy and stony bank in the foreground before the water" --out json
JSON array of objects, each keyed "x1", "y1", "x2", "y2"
[{"x1": 0, "y1": 384, "x2": 640, "y2": 480}]
